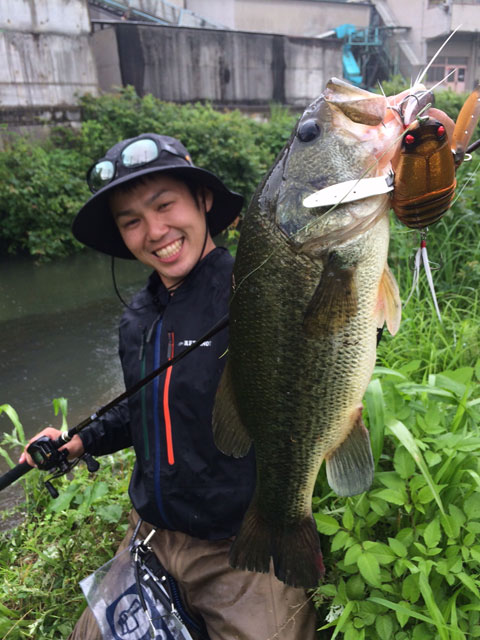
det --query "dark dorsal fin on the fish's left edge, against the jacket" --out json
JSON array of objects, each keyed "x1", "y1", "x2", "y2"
[{"x1": 212, "y1": 362, "x2": 252, "y2": 458}]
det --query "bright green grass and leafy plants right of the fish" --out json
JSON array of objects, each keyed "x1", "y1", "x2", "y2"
[{"x1": 314, "y1": 165, "x2": 480, "y2": 640}]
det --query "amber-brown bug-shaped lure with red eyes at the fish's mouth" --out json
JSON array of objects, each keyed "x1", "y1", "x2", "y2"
[{"x1": 391, "y1": 86, "x2": 480, "y2": 321}]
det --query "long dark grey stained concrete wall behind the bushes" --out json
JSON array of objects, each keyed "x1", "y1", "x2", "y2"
[{"x1": 106, "y1": 23, "x2": 342, "y2": 107}]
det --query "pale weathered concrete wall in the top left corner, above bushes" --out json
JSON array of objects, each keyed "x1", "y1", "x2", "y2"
[{"x1": 0, "y1": 0, "x2": 98, "y2": 113}]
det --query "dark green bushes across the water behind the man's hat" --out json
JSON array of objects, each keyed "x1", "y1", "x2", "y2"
[{"x1": 0, "y1": 87, "x2": 295, "y2": 260}]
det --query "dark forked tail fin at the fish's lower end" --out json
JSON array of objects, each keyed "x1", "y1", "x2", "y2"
[{"x1": 230, "y1": 499, "x2": 325, "y2": 589}]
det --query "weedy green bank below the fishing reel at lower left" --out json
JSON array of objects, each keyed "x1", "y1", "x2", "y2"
[{"x1": 0, "y1": 399, "x2": 133, "y2": 640}]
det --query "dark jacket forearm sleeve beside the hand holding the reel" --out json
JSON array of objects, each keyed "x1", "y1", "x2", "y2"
[{"x1": 78, "y1": 400, "x2": 132, "y2": 456}]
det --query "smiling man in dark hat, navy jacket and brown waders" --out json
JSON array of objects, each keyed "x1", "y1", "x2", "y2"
[{"x1": 21, "y1": 134, "x2": 315, "y2": 640}]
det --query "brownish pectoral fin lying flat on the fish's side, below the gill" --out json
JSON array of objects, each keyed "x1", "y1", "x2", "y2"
[{"x1": 303, "y1": 258, "x2": 358, "y2": 337}]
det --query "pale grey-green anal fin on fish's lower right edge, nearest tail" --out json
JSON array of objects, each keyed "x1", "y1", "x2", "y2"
[{"x1": 326, "y1": 409, "x2": 375, "y2": 496}]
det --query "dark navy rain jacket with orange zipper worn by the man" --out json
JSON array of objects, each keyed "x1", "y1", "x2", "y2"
[{"x1": 80, "y1": 248, "x2": 255, "y2": 540}]
